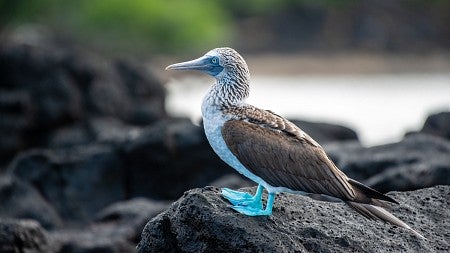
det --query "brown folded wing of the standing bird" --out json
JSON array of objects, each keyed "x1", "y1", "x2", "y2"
[{"x1": 222, "y1": 120, "x2": 355, "y2": 200}]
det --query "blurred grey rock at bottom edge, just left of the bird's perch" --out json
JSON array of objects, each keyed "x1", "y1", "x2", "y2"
[{"x1": 49, "y1": 198, "x2": 169, "y2": 253}]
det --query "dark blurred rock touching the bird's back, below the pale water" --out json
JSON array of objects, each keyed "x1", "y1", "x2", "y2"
[{"x1": 291, "y1": 120, "x2": 358, "y2": 143}]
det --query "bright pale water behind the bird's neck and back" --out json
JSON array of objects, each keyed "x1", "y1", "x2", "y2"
[{"x1": 166, "y1": 73, "x2": 450, "y2": 146}]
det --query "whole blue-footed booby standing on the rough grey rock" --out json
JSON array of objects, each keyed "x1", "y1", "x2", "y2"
[{"x1": 166, "y1": 47, "x2": 423, "y2": 238}]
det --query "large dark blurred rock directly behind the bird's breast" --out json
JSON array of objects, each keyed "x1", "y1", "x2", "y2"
[{"x1": 123, "y1": 119, "x2": 233, "y2": 199}]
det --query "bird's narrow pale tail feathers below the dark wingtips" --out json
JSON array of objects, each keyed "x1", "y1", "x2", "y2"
[{"x1": 346, "y1": 201, "x2": 425, "y2": 239}]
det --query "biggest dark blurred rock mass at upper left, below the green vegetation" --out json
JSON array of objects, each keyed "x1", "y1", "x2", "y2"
[{"x1": 0, "y1": 28, "x2": 166, "y2": 162}]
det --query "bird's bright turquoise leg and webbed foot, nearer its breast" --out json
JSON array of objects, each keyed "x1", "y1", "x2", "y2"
[{"x1": 222, "y1": 185, "x2": 264, "y2": 209}]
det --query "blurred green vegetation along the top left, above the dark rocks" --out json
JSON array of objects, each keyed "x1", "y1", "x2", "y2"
[{"x1": 0, "y1": 0, "x2": 232, "y2": 55}]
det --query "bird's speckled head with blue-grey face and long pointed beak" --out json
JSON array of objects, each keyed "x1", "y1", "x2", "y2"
[{"x1": 166, "y1": 47, "x2": 250, "y2": 82}]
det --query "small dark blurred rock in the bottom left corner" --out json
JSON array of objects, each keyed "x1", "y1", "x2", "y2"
[{"x1": 0, "y1": 219, "x2": 50, "y2": 253}]
